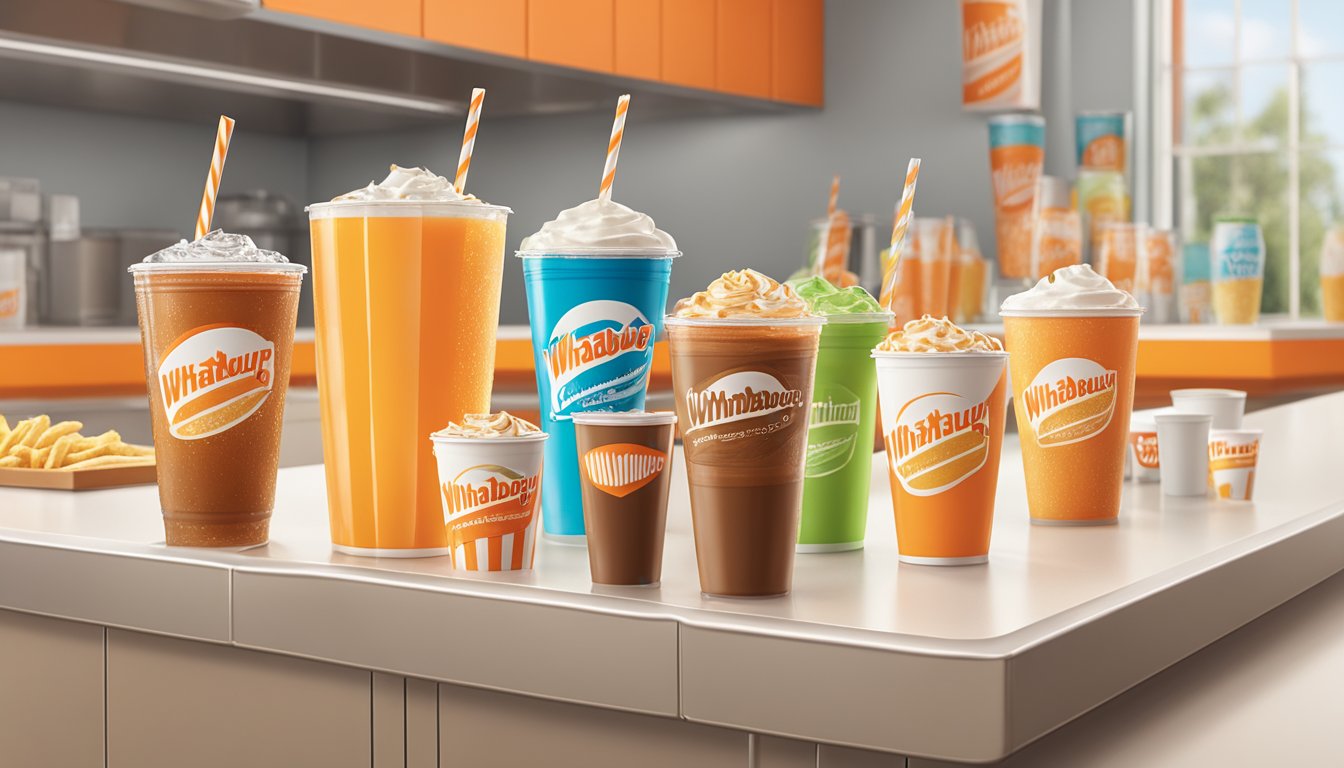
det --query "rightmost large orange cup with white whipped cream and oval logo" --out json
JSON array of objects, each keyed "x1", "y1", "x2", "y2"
[{"x1": 1000, "y1": 265, "x2": 1142, "y2": 525}]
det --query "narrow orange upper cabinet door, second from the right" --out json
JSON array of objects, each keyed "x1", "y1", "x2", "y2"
[{"x1": 715, "y1": 0, "x2": 773, "y2": 98}]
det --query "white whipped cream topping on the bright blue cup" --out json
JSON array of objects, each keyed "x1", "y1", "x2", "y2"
[{"x1": 519, "y1": 198, "x2": 676, "y2": 253}]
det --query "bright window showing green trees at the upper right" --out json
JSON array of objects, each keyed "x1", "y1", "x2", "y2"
[{"x1": 1153, "y1": 0, "x2": 1344, "y2": 317}]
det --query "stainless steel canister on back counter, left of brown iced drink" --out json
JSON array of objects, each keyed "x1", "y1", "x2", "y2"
[{"x1": 39, "y1": 230, "x2": 126, "y2": 325}]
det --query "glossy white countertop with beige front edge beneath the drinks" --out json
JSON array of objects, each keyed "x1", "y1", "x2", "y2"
[{"x1": 0, "y1": 393, "x2": 1344, "y2": 760}]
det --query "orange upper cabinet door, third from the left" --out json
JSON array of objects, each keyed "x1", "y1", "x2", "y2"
[{"x1": 527, "y1": 0, "x2": 616, "y2": 73}]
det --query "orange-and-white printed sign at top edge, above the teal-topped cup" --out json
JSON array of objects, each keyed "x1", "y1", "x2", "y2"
[{"x1": 961, "y1": 0, "x2": 1042, "y2": 109}]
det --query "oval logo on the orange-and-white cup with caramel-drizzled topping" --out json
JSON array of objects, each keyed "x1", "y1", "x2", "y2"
[{"x1": 887, "y1": 391, "x2": 989, "y2": 496}]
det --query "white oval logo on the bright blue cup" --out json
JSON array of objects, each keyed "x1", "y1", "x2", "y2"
[{"x1": 542, "y1": 300, "x2": 653, "y2": 413}]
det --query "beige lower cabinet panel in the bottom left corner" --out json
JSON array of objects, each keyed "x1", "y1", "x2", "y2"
[{"x1": 0, "y1": 611, "x2": 103, "y2": 768}]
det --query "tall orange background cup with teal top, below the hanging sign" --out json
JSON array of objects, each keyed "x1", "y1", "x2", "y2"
[{"x1": 989, "y1": 114, "x2": 1046, "y2": 278}]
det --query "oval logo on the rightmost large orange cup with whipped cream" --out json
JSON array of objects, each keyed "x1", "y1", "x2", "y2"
[{"x1": 1021, "y1": 358, "x2": 1117, "y2": 448}]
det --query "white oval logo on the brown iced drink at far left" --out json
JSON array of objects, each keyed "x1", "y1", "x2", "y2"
[{"x1": 157, "y1": 324, "x2": 276, "y2": 440}]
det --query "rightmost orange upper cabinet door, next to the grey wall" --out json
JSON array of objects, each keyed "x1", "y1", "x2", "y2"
[{"x1": 770, "y1": 0, "x2": 827, "y2": 106}]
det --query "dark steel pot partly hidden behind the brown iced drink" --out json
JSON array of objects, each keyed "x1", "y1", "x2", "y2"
[{"x1": 212, "y1": 190, "x2": 313, "y2": 327}]
